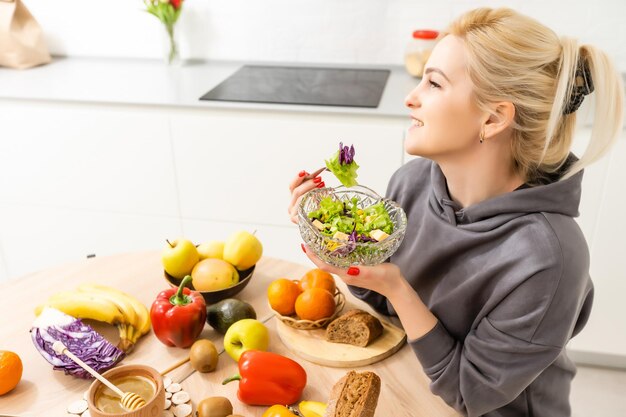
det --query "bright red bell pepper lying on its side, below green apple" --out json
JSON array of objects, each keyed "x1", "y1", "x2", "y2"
[{"x1": 222, "y1": 350, "x2": 306, "y2": 405}]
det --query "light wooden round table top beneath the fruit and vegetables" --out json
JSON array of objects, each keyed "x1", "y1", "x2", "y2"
[{"x1": 0, "y1": 252, "x2": 457, "y2": 417}]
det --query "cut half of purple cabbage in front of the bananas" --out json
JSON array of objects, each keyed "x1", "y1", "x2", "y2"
[{"x1": 30, "y1": 307, "x2": 125, "y2": 379}]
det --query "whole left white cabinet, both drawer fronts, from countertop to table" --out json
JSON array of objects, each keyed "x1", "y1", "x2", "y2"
[{"x1": 0, "y1": 102, "x2": 181, "y2": 278}]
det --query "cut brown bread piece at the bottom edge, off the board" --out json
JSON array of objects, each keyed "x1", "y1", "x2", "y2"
[{"x1": 324, "y1": 371, "x2": 380, "y2": 417}]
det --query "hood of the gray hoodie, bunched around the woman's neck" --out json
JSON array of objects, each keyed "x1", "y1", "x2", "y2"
[{"x1": 429, "y1": 154, "x2": 583, "y2": 231}]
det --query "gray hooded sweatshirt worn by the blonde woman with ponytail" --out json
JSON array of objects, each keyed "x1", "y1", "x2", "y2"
[{"x1": 351, "y1": 158, "x2": 593, "y2": 417}]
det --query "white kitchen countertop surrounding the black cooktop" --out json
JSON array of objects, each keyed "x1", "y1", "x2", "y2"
[{"x1": 0, "y1": 57, "x2": 418, "y2": 117}]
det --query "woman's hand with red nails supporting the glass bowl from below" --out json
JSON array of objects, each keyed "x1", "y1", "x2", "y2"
[{"x1": 302, "y1": 244, "x2": 406, "y2": 299}]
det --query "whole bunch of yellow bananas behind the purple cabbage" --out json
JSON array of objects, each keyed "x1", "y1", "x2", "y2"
[{"x1": 35, "y1": 283, "x2": 150, "y2": 353}]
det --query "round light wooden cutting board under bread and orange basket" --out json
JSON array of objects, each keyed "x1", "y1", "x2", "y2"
[{"x1": 275, "y1": 310, "x2": 406, "y2": 368}]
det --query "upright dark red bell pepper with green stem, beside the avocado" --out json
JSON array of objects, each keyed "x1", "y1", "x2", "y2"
[{"x1": 150, "y1": 275, "x2": 206, "y2": 348}]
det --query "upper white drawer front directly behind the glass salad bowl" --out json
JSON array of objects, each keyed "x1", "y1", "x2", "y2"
[{"x1": 172, "y1": 111, "x2": 403, "y2": 226}]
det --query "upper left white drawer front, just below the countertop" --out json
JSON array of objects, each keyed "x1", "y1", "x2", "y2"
[{"x1": 0, "y1": 102, "x2": 178, "y2": 216}]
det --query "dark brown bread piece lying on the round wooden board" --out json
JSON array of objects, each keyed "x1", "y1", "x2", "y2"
[{"x1": 326, "y1": 310, "x2": 383, "y2": 347}]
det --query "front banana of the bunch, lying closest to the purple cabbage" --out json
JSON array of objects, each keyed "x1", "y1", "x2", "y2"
[{"x1": 35, "y1": 291, "x2": 125, "y2": 325}]
